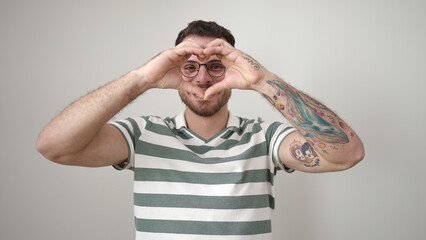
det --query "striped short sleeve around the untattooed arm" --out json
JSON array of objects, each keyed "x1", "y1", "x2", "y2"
[{"x1": 108, "y1": 118, "x2": 137, "y2": 170}]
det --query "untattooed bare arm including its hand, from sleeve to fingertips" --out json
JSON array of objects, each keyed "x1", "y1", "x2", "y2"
[{"x1": 36, "y1": 40, "x2": 204, "y2": 167}]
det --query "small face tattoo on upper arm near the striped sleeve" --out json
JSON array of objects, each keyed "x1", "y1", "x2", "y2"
[{"x1": 290, "y1": 141, "x2": 320, "y2": 167}]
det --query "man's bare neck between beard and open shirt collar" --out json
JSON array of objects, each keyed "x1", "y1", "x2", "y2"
[{"x1": 185, "y1": 105, "x2": 229, "y2": 140}]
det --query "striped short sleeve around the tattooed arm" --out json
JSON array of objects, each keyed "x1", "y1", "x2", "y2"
[{"x1": 266, "y1": 121, "x2": 296, "y2": 173}]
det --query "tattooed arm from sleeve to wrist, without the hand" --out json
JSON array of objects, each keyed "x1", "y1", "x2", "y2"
[{"x1": 259, "y1": 77, "x2": 364, "y2": 172}]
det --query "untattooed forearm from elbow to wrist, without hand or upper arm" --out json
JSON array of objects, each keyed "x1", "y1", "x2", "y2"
[{"x1": 37, "y1": 71, "x2": 147, "y2": 162}]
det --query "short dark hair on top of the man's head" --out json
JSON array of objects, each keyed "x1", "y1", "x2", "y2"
[{"x1": 175, "y1": 20, "x2": 235, "y2": 46}]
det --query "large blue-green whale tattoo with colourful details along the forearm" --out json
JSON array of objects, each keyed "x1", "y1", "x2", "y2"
[{"x1": 264, "y1": 80, "x2": 349, "y2": 144}]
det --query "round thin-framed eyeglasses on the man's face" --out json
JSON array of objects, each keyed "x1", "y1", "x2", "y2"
[{"x1": 180, "y1": 61, "x2": 226, "y2": 78}]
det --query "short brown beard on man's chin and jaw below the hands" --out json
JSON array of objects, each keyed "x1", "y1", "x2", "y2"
[{"x1": 179, "y1": 90, "x2": 231, "y2": 117}]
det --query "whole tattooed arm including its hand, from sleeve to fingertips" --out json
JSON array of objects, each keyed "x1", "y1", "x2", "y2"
[{"x1": 205, "y1": 40, "x2": 364, "y2": 172}]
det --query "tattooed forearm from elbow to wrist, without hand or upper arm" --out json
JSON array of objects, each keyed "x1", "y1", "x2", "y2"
[{"x1": 260, "y1": 76, "x2": 362, "y2": 163}]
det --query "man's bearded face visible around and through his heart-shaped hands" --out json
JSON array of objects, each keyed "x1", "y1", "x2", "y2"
[{"x1": 179, "y1": 35, "x2": 231, "y2": 117}]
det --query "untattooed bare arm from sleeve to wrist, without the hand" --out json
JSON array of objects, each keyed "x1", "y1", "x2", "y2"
[{"x1": 36, "y1": 71, "x2": 148, "y2": 167}]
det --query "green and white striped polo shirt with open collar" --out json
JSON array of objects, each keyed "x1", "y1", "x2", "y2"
[{"x1": 110, "y1": 113, "x2": 295, "y2": 240}]
